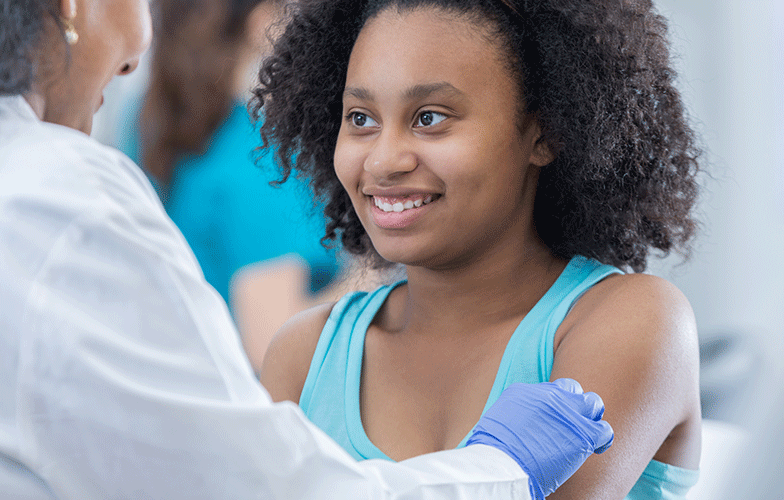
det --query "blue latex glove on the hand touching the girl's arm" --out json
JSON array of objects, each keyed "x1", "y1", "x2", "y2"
[{"x1": 467, "y1": 379, "x2": 613, "y2": 500}]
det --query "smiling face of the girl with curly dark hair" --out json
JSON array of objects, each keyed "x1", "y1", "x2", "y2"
[{"x1": 335, "y1": 9, "x2": 551, "y2": 268}]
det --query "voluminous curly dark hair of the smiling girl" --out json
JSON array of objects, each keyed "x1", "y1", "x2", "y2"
[{"x1": 252, "y1": 0, "x2": 700, "y2": 271}]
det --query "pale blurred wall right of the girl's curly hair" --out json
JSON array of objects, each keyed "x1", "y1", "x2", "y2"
[{"x1": 657, "y1": 0, "x2": 784, "y2": 338}]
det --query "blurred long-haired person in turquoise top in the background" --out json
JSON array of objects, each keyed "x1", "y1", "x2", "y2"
[{"x1": 108, "y1": 0, "x2": 370, "y2": 368}]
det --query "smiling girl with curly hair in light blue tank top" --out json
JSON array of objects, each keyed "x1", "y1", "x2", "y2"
[{"x1": 256, "y1": 0, "x2": 700, "y2": 500}]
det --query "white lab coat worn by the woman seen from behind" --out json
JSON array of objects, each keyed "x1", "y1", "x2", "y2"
[{"x1": 0, "y1": 96, "x2": 529, "y2": 500}]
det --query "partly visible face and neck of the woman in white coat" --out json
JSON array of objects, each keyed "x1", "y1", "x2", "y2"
[{"x1": 38, "y1": 0, "x2": 152, "y2": 134}]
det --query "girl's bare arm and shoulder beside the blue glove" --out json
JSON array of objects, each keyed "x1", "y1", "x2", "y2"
[{"x1": 548, "y1": 274, "x2": 699, "y2": 500}]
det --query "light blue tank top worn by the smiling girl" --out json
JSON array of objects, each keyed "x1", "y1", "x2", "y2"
[{"x1": 299, "y1": 256, "x2": 698, "y2": 500}]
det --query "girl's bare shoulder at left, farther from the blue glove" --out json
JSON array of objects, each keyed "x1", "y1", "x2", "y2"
[{"x1": 260, "y1": 302, "x2": 335, "y2": 403}]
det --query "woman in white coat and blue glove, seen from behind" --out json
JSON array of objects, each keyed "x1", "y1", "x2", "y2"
[{"x1": 0, "y1": 0, "x2": 612, "y2": 500}]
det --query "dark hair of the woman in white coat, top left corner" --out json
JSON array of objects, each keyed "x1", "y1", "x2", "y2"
[{"x1": 0, "y1": 0, "x2": 63, "y2": 95}]
